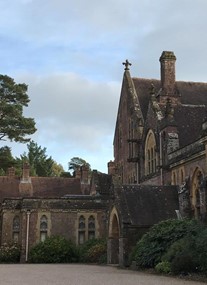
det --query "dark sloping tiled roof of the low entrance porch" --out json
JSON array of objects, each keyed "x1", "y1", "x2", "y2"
[{"x1": 115, "y1": 185, "x2": 179, "y2": 226}]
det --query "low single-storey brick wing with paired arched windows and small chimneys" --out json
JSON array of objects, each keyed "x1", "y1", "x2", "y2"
[{"x1": 0, "y1": 165, "x2": 111, "y2": 262}]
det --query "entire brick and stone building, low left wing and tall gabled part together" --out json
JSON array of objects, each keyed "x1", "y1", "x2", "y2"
[{"x1": 0, "y1": 51, "x2": 207, "y2": 266}]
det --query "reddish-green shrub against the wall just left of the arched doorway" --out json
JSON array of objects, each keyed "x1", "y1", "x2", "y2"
[{"x1": 80, "y1": 239, "x2": 107, "y2": 263}]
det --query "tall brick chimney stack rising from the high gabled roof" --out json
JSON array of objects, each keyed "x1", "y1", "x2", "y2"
[{"x1": 160, "y1": 51, "x2": 176, "y2": 97}]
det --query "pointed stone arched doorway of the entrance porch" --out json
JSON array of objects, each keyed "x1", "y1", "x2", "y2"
[{"x1": 107, "y1": 207, "x2": 120, "y2": 264}]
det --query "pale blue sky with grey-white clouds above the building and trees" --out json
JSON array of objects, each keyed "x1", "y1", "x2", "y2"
[{"x1": 0, "y1": 0, "x2": 207, "y2": 172}]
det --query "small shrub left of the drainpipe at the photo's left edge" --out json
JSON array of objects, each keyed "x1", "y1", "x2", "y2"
[{"x1": 0, "y1": 244, "x2": 20, "y2": 263}]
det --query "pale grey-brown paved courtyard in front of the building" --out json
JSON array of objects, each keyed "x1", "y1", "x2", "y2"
[{"x1": 0, "y1": 264, "x2": 204, "y2": 285}]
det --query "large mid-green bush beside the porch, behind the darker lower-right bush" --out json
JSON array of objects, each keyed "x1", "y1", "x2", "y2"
[{"x1": 132, "y1": 220, "x2": 203, "y2": 268}]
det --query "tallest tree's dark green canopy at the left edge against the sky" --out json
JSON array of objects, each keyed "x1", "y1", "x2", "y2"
[{"x1": 0, "y1": 75, "x2": 36, "y2": 143}]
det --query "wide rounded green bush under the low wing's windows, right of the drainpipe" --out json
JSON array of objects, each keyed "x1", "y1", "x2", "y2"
[{"x1": 29, "y1": 236, "x2": 79, "y2": 263}]
